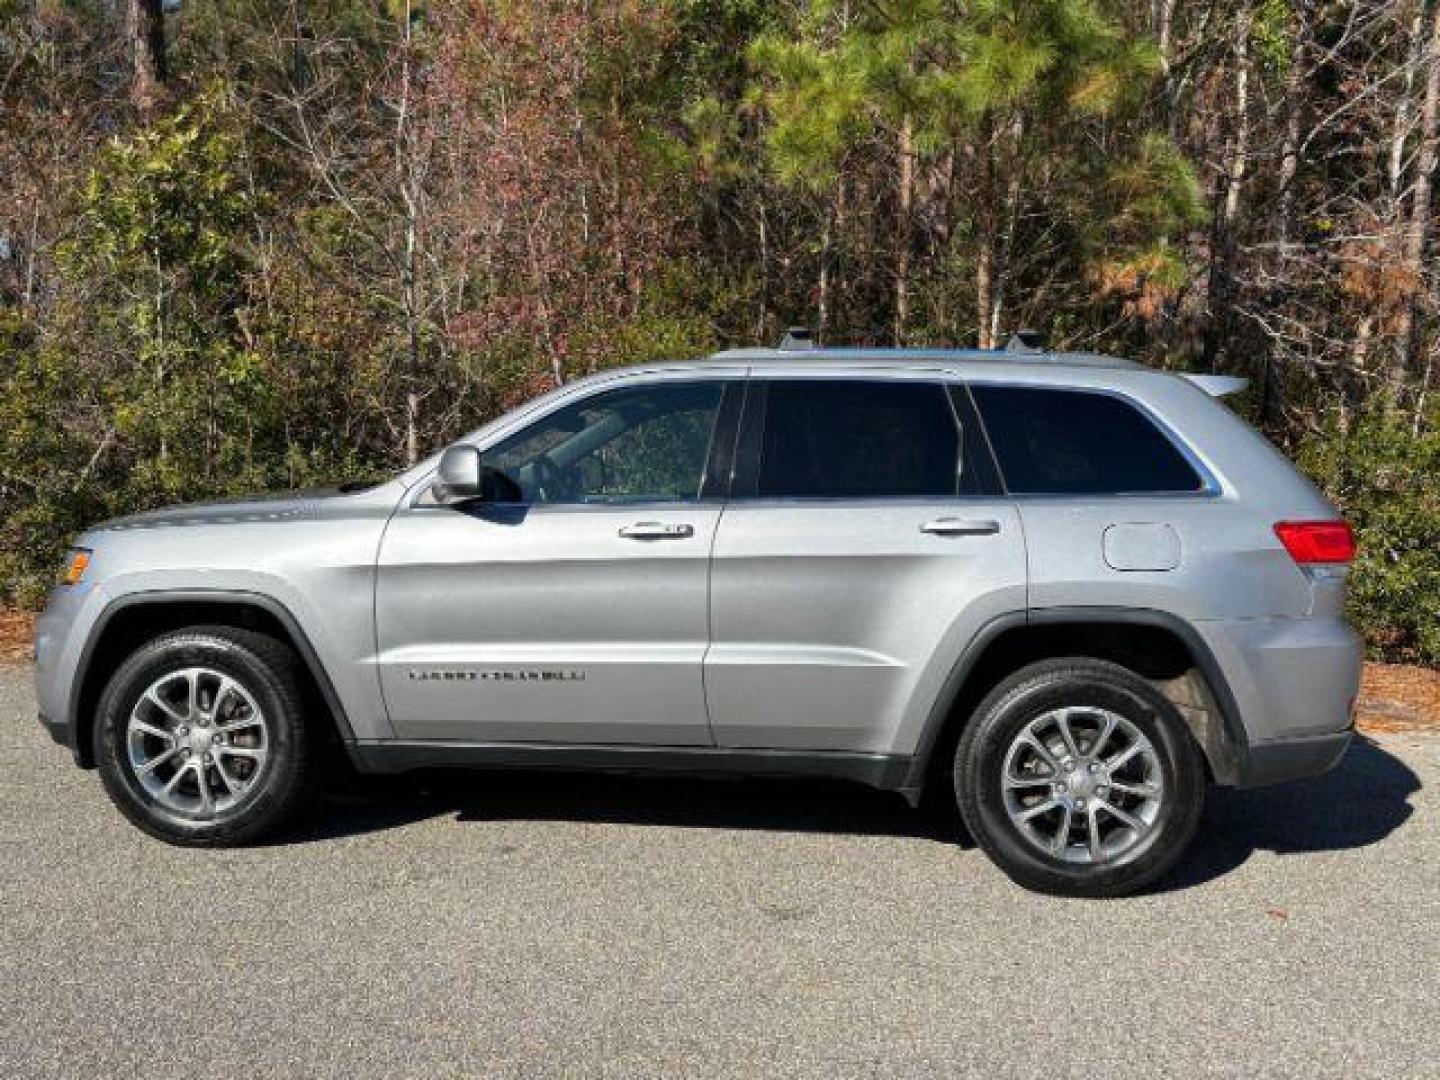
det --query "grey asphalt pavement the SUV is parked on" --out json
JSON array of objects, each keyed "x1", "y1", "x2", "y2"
[{"x1": 0, "y1": 668, "x2": 1440, "y2": 1080}]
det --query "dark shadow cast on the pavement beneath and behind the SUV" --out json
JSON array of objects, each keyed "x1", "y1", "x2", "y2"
[{"x1": 276, "y1": 737, "x2": 1420, "y2": 893}]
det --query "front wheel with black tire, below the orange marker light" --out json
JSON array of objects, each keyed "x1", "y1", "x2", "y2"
[{"x1": 95, "y1": 626, "x2": 312, "y2": 847}]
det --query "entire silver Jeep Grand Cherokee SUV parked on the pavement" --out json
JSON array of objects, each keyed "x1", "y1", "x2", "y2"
[{"x1": 36, "y1": 347, "x2": 1361, "y2": 896}]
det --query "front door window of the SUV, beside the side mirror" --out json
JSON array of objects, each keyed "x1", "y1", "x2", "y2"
[{"x1": 485, "y1": 382, "x2": 724, "y2": 504}]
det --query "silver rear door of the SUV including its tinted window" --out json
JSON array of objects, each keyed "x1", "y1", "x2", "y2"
[{"x1": 706, "y1": 372, "x2": 1025, "y2": 753}]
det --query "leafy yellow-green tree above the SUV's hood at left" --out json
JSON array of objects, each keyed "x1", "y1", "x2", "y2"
[{"x1": 55, "y1": 88, "x2": 266, "y2": 498}]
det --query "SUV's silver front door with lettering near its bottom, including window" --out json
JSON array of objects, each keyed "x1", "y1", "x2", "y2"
[{"x1": 376, "y1": 374, "x2": 740, "y2": 746}]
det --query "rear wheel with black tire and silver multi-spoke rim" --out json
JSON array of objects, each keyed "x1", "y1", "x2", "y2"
[{"x1": 953, "y1": 658, "x2": 1205, "y2": 897}]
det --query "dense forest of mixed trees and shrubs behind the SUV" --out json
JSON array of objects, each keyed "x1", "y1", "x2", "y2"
[{"x1": 0, "y1": 0, "x2": 1440, "y2": 665}]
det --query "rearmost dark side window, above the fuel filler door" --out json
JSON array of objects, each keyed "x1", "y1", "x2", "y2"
[{"x1": 971, "y1": 386, "x2": 1202, "y2": 495}]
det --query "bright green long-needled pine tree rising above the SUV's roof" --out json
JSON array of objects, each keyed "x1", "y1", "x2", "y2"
[{"x1": 752, "y1": 0, "x2": 1189, "y2": 348}]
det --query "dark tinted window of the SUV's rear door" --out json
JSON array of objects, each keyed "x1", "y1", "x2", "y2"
[{"x1": 756, "y1": 379, "x2": 959, "y2": 498}]
